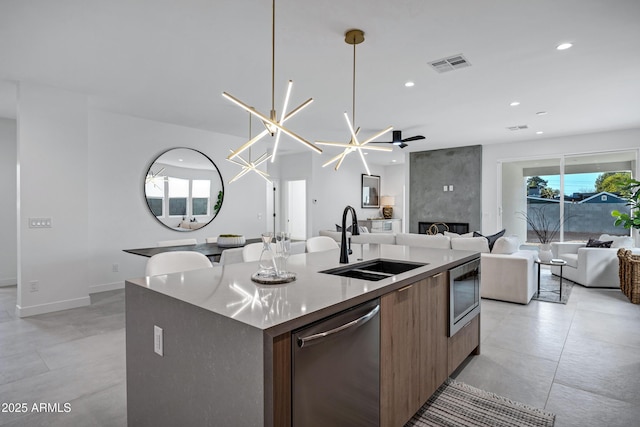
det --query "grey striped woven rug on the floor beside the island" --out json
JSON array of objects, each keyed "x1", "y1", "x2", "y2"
[{"x1": 405, "y1": 378, "x2": 556, "y2": 427}]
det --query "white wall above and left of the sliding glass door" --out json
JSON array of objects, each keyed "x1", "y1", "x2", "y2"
[{"x1": 482, "y1": 129, "x2": 640, "y2": 233}]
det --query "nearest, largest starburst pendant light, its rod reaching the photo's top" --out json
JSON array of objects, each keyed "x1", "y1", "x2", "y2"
[{"x1": 222, "y1": 0, "x2": 322, "y2": 162}]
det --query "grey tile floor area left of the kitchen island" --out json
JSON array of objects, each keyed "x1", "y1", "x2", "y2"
[{"x1": 0, "y1": 287, "x2": 127, "y2": 427}]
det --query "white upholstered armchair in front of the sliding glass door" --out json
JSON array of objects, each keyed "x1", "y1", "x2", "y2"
[{"x1": 551, "y1": 234, "x2": 634, "y2": 288}]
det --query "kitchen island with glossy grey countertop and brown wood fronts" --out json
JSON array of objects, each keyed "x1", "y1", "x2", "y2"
[{"x1": 126, "y1": 244, "x2": 479, "y2": 426}]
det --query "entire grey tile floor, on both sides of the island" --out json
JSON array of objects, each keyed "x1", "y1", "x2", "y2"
[{"x1": 0, "y1": 268, "x2": 640, "y2": 427}]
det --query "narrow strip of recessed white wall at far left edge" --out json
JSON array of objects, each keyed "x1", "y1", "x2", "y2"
[{"x1": 0, "y1": 118, "x2": 18, "y2": 286}]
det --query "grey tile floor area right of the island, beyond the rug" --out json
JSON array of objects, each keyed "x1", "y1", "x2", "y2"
[{"x1": 455, "y1": 270, "x2": 640, "y2": 427}]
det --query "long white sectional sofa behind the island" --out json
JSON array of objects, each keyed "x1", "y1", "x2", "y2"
[{"x1": 319, "y1": 230, "x2": 538, "y2": 304}]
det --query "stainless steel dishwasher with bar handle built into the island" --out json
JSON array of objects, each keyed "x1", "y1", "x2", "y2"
[{"x1": 292, "y1": 299, "x2": 380, "y2": 427}]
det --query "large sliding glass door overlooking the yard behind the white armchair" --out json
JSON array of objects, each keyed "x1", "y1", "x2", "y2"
[{"x1": 500, "y1": 151, "x2": 637, "y2": 245}]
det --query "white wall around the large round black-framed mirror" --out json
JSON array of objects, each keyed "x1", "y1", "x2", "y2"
[{"x1": 88, "y1": 111, "x2": 268, "y2": 292}]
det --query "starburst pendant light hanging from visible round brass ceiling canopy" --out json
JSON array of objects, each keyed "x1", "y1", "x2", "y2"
[{"x1": 316, "y1": 30, "x2": 393, "y2": 175}]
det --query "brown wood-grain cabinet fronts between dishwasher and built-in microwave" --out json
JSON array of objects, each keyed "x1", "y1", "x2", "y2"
[{"x1": 380, "y1": 272, "x2": 480, "y2": 427}]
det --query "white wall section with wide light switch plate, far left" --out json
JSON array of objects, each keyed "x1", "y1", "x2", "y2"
[{"x1": 16, "y1": 83, "x2": 89, "y2": 316}]
